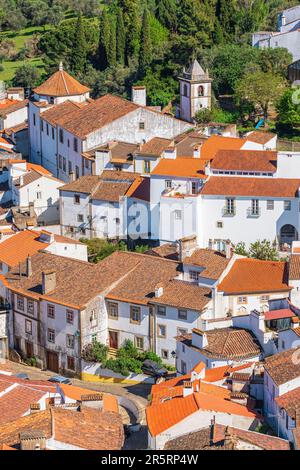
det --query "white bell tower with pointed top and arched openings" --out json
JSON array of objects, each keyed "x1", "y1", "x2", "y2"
[{"x1": 179, "y1": 60, "x2": 212, "y2": 122}]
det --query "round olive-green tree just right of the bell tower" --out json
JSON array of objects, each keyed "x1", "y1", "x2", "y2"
[{"x1": 235, "y1": 71, "x2": 286, "y2": 120}]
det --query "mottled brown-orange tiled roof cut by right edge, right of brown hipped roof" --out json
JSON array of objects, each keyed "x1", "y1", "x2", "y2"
[{"x1": 264, "y1": 348, "x2": 300, "y2": 386}]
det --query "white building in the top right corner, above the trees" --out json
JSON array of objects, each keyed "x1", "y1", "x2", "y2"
[{"x1": 252, "y1": 5, "x2": 300, "y2": 61}]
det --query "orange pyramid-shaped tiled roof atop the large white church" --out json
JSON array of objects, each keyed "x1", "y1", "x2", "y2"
[{"x1": 33, "y1": 70, "x2": 90, "y2": 97}]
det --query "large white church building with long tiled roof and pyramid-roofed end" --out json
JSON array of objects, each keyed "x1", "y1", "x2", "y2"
[{"x1": 29, "y1": 66, "x2": 191, "y2": 182}]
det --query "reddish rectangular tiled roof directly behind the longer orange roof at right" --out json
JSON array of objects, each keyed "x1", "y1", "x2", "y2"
[{"x1": 210, "y1": 150, "x2": 277, "y2": 173}]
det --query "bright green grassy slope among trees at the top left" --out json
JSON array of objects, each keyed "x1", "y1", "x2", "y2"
[{"x1": 0, "y1": 26, "x2": 50, "y2": 81}]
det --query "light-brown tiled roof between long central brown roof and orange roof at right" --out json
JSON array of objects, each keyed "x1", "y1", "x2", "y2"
[{"x1": 151, "y1": 280, "x2": 211, "y2": 312}]
